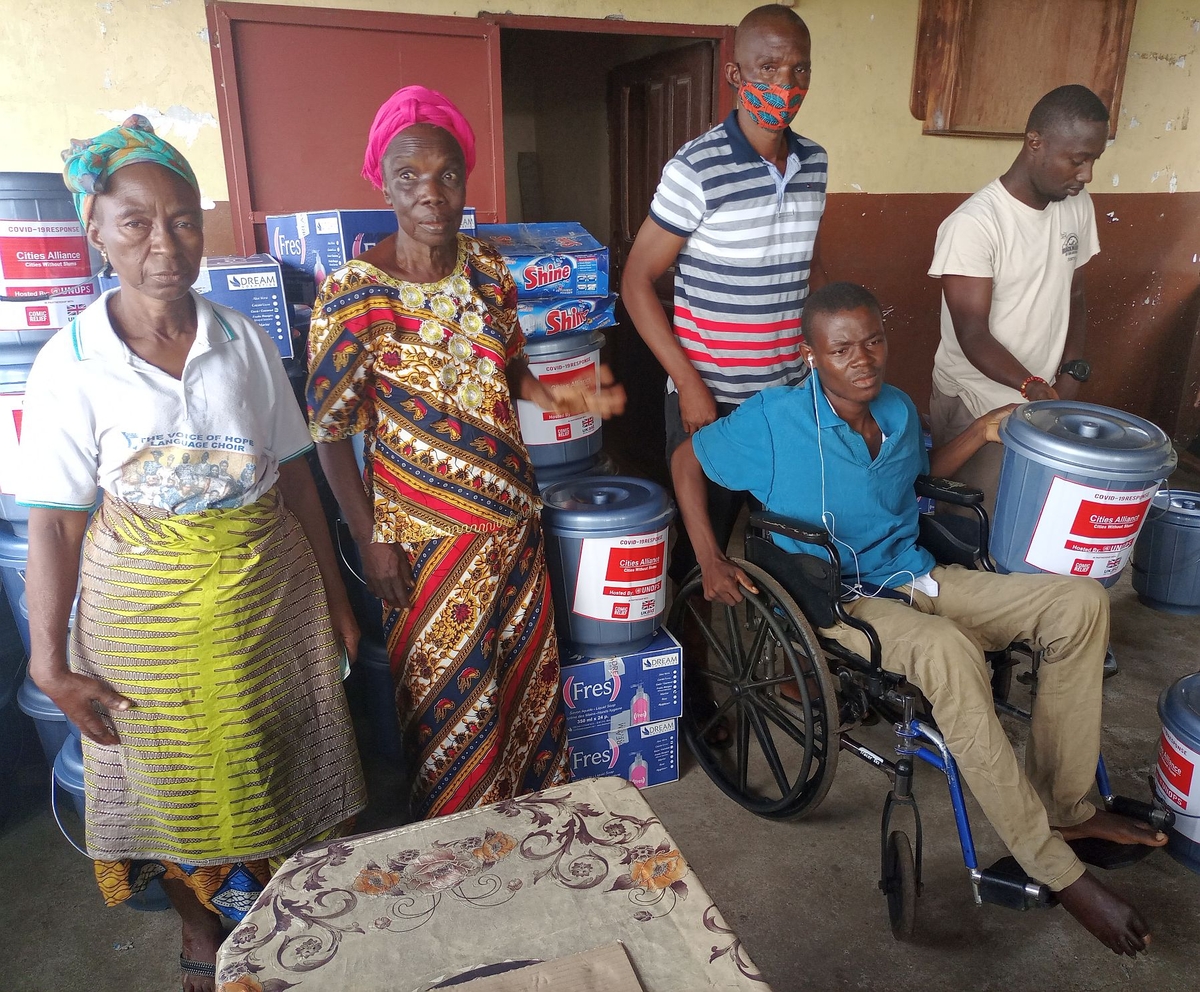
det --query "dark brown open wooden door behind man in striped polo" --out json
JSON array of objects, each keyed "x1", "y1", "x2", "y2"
[{"x1": 605, "y1": 41, "x2": 726, "y2": 483}]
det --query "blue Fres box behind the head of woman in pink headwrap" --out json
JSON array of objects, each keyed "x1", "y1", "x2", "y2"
[{"x1": 266, "y1": 206, "x2": 475, "y2": 306}]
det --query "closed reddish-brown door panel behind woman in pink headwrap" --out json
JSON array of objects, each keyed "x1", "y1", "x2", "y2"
[{"x1": 208, "y1": 0, "x2": 504, "y2": 254}]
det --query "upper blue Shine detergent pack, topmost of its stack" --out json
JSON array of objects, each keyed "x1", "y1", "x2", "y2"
[{"x1": 478, "y1": 222, "x2": 608, "y2": 300}]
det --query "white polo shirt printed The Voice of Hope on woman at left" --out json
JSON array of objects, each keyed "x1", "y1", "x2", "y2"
[{"x1": 17, "y1": 290, "x2": 312, "y2": 513}]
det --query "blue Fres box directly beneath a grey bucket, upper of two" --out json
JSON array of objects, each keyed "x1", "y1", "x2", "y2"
[{"x1": 560, "y1": 629, "x2": 683, "y2": 737}]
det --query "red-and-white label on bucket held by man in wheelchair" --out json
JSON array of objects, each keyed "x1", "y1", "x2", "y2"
[{"x1": 1025, "y1": 477, "x2": 1158, "y2": 578}]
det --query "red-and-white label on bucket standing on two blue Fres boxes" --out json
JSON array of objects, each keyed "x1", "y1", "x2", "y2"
[{"x1": 571, "y1": 528, "x2": 667, "y2": 624}]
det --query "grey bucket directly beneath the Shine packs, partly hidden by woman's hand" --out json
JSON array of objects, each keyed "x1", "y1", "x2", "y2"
[{"x1": 517, "y1": 331, "x2": 604, "y2": 469}]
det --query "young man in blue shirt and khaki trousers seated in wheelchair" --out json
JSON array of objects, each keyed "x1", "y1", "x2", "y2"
[{"x1": 671, "y1": 283, "x2": 1166, "y2": 955}]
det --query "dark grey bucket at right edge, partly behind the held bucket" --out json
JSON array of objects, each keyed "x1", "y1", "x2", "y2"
[{"x1": 1132, "y1": 489, "x2": 1200, "y2": 614}]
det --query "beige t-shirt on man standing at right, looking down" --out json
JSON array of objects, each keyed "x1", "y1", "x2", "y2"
[{"x1": 929, "y1": 179, "x2": 1100, "y2": 416}]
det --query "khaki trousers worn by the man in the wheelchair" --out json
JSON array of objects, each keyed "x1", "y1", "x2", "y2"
[{"x1": 823, "y1": 565, "x2": 1109, "y2": 891}]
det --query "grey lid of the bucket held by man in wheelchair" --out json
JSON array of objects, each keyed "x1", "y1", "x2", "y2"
[{"x1": 1001, "y1": 399, "x2": 1178, "y2": 482}]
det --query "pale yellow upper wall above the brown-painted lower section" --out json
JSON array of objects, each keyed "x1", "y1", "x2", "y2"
[{"x1": 0, "y1": 0, "x2": 1200, "y2": 200}]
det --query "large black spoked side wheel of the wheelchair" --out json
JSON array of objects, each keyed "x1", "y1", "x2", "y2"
[{"x1": 667, "y1": 559, "x2": 839, "y2": 819}]
